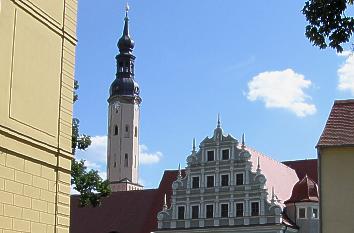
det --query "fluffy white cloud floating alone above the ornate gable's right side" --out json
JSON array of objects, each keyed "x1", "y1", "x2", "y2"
[{"x1": 247, "y1": 69, "x2": 317, "y2": 117}]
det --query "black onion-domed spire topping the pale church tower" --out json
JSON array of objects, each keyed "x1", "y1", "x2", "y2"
[{"x1": 109, "y1": 5, "x2": 141, "y2": 103}]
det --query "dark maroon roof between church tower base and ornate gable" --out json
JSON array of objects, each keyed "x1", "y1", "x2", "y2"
[{"x1": 70, "y1": 170, "x2": 184, "y2": 233}]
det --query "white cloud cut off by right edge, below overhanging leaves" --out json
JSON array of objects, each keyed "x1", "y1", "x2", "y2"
[{"x1": 337, "y1": 51, "x2": 354, "y2": 96}]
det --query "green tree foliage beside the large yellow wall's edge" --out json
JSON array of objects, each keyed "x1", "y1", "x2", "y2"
[{"x1": 71, "y1": 81, "x2": 111, "y2": 207}]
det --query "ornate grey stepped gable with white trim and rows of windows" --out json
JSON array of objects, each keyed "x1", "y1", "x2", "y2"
[{"x1": 157, "y1": 122, "x2": 290, "y2": 231}]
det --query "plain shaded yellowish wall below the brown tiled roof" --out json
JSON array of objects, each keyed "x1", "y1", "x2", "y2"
[{"x1": 319, "y1": 147, "x2": 354, "y2": 233}]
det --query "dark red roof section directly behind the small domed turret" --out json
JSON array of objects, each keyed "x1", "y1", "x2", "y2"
[{"x1": 282, "y1": 159, "x2": 318, "y2": 183}]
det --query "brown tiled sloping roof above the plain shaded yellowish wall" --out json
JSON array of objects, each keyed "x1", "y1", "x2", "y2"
[{"x1": 317, "y1": 99, "x2": 354, "y2": 147}]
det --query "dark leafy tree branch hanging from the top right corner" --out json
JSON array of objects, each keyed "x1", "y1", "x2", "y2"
[{"x1": 302, "y1": 0, "x2": 354, "y2": 53}]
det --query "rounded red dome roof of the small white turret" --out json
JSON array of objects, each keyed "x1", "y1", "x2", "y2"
[{"x1": 284, "y1": 175, "x2": 319, "y2": 204}]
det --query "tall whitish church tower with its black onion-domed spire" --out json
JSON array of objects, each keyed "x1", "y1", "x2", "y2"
[{"x1": 107, "y1": 5, "x2": 143, "y2": 192}]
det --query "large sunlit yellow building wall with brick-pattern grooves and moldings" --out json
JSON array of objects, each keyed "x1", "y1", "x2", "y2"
[{"x1": 0, "y1": 0, "x2": 77, "y2": 233}]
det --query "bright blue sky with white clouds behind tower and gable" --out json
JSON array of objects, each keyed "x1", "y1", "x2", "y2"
[{"x1": 74, "y1": 0, "x2": 354, "y2": 188}]
